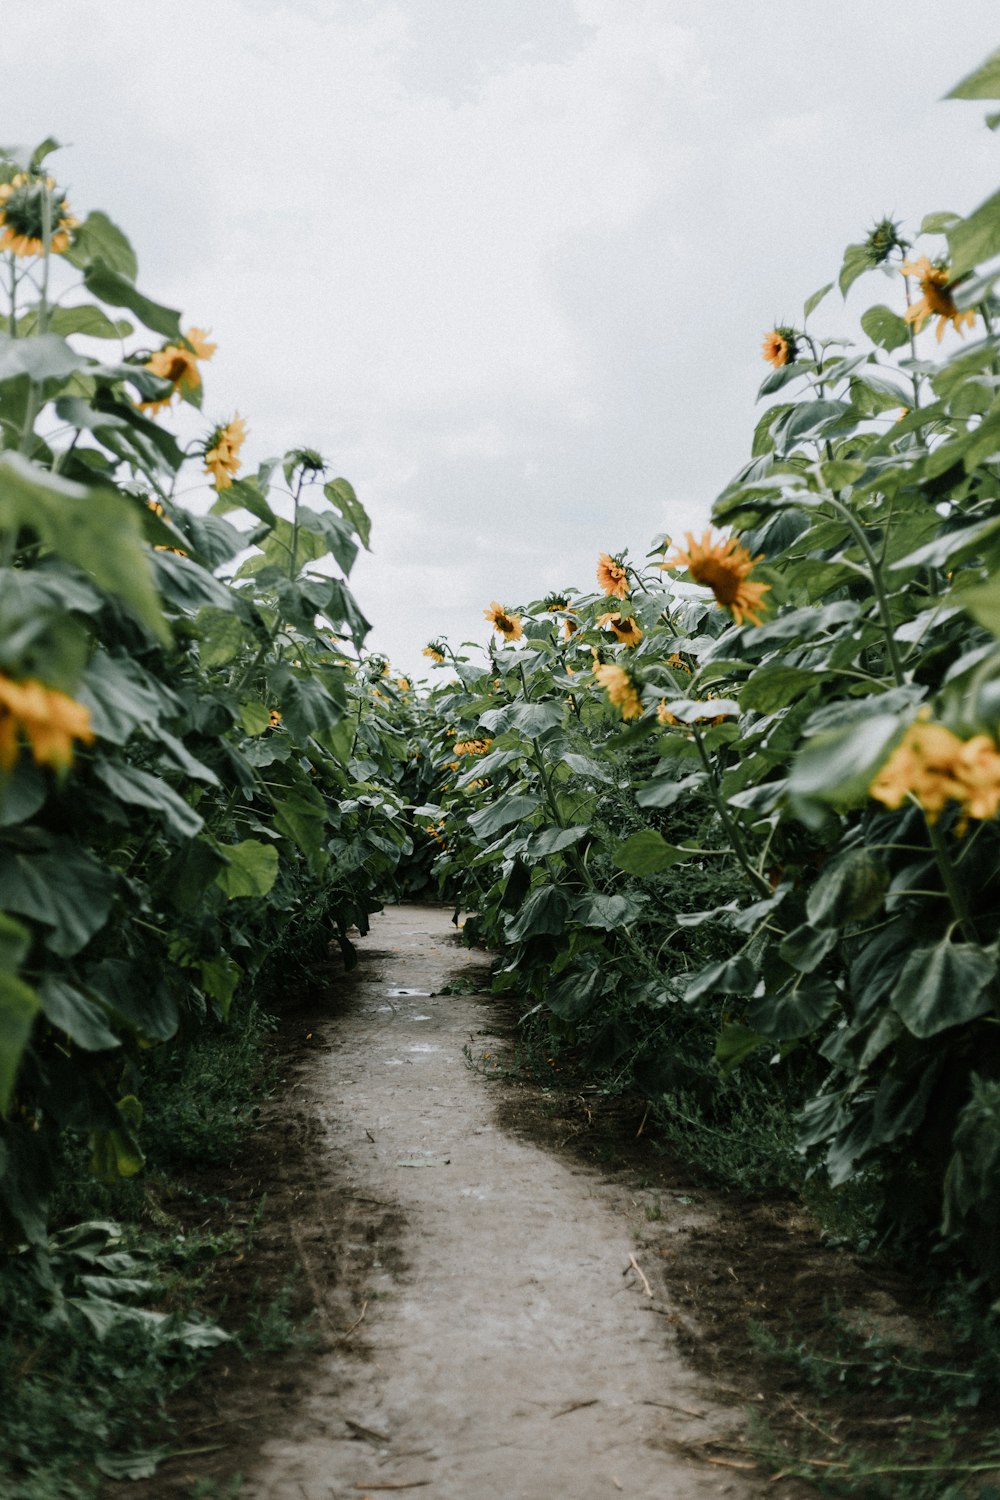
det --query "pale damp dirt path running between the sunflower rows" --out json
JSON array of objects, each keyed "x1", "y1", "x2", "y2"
[{"x1": 241, "y1": 906, "x2": 774, "y2": 1500}]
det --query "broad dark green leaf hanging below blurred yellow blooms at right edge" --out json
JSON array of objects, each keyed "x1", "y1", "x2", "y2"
[{"x1": 889, "y1": 939, "x2": 997, "y2": 1037}]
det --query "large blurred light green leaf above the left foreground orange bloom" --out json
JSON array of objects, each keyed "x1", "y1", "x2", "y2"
[{"x1": 0, "y1": 453, "x2": 169, "y2": 644}]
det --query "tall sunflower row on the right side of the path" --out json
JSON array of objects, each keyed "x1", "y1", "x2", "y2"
[{"x1": 418, "y1": 59, "x2": 1000, "y2": 1284}]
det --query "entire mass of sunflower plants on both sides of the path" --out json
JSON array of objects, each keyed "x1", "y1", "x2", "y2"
[{"x1": 0, "y1": 54, "x2": 1000, "y2": 1416}]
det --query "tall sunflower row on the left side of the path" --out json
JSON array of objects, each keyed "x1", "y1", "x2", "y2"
[{"x1": 0, "y1": 141, "x2": 425, "y2": 1283}]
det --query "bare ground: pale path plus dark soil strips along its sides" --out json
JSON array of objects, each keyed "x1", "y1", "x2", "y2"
[{"x1": 108, "y1": 906, "x2": 953, "y2": 1500}]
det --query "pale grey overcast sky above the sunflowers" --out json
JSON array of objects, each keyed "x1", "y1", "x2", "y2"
[{"x1": 7, "y1": 0, "x2": 1000, "y2": 672}]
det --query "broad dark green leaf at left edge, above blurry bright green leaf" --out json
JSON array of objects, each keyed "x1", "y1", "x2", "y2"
[{"x1": 0, "y1": 840, "x2": 114, "y2": 957}]
